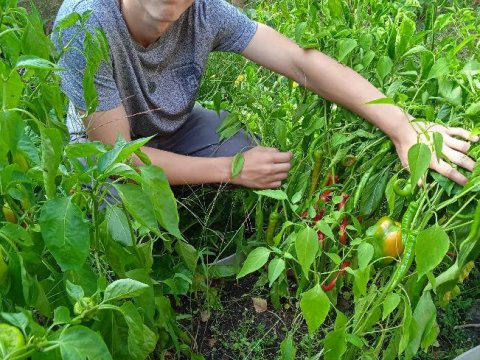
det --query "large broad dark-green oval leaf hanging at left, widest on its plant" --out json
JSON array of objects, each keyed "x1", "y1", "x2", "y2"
[{"x1": 39, "y1": 198, "x2": 90, "y2": 271}]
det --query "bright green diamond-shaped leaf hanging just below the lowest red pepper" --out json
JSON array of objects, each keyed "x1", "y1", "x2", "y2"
[{"x1": 300, "y1": 284, "x2": 330, "y2": 335}]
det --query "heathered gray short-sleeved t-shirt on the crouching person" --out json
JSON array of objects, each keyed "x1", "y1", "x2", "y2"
[{"x1": 54, "y1": 0, "x2": 257, "y2": 138}]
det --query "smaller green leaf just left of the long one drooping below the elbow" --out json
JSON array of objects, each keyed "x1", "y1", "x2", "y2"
[{"x1": 114, "y1": 184, "x2": 160, "y2": 235}]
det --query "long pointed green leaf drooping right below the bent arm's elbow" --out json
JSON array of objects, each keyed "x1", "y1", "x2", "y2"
[{"x1": 140, "y1": 166, "x2": 182, "y2": 239}]
